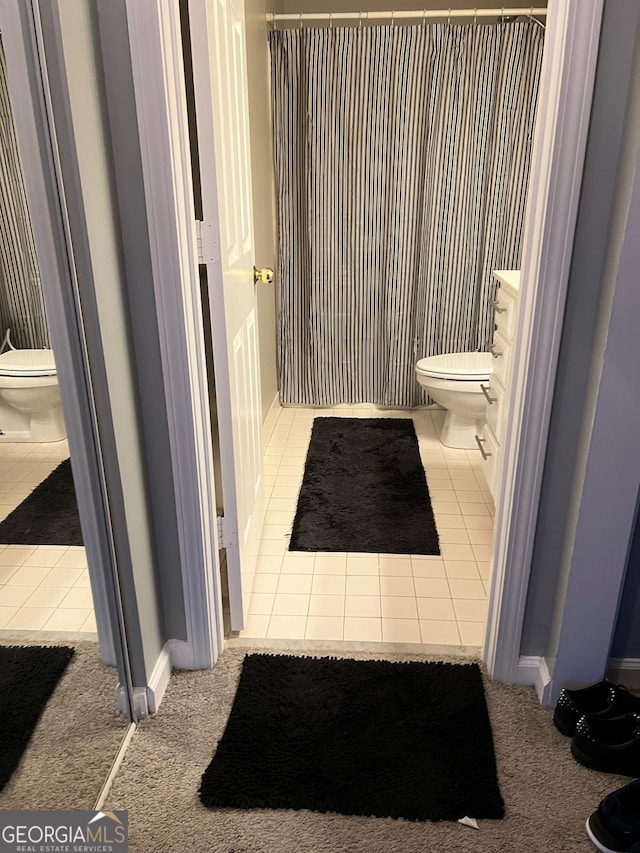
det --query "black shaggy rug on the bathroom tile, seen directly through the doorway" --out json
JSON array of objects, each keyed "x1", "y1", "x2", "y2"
[{"x1": 289, "y1": 418, "x2": 440, "y2": 556}]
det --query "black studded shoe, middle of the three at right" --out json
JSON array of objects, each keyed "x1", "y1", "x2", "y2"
[{"x1": 571, "y1": 714, "x2": 640, "y2": 777}]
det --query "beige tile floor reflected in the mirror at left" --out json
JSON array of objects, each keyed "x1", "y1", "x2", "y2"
[{"x1": 0, "y1": 441, "x2": 96, "y2": 637}]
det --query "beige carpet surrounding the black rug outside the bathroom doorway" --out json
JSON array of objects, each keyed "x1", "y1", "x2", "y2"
[{"x1": 108, "y1": 649, "x2": 629, "y2": 853}]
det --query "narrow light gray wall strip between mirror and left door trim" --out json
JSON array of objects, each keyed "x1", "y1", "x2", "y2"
[{"x1": 41, "y1": 0, "x2": 171, "y2": 685}]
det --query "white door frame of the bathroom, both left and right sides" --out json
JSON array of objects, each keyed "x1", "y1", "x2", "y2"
[{"x1": 126, "y1": 0, "x2": 603, "y2": 683}]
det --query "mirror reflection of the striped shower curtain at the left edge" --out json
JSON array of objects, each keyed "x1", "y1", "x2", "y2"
[{"x1": 0, "y1": 44, "x2": 50, "y2": 349}]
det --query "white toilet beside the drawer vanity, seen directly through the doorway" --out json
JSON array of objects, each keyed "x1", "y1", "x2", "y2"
[{"x1": 416, "y1": 352, "x2": 493, "y2": 449}]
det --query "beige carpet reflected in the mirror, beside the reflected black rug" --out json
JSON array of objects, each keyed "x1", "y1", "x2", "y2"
[{"x1": 0, "y1": 641, "x2": 127, "y2": 809}]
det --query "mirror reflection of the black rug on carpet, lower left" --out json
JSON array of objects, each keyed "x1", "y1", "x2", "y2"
[{"x1": 0, "y1": 646, "x2": 73, "y2": 792}]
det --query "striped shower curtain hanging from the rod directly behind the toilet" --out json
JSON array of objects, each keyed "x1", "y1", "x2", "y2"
[{"x1": 270, "y1": 22, "x2": 543, "y2": 407}]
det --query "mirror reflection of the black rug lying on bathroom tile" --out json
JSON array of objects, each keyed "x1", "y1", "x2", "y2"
[{"x1": 0, "y1": 459, "x2": 82, "y2": 545}]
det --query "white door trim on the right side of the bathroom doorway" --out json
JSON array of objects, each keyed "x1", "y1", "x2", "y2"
[{"x1": 483, "y1": 0, "x2": 603, "y2": 684}]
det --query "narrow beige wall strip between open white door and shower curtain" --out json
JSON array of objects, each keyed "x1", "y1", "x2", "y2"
[{"x1": 244, "y1": 0, "x2": 282, "y2": 419}]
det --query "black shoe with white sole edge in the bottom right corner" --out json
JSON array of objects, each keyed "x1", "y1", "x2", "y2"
[{"x1": 587, "y1": 779, "x2": 640, "y2": 853}]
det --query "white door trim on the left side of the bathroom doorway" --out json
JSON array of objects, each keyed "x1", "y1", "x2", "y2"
[{"x1": 125, "y1": 0, "x2": 224, "y2": 669}]
